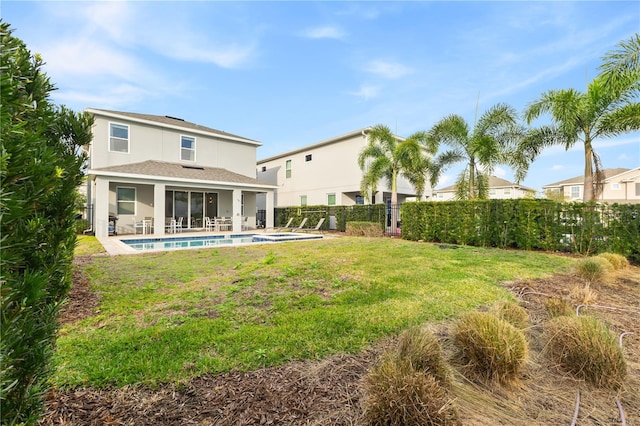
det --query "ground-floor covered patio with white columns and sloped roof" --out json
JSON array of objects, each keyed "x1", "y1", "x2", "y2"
[{"x1": 88, "y1": 161, "x2": 275, "y2": 237}]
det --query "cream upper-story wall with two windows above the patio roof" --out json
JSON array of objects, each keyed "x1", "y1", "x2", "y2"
[{"x1": 89, "y1": 110, "x2": 260, "y2": 176}]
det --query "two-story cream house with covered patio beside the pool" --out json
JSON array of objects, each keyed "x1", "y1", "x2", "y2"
[{"x1": 85, "y1": 109, "x2": 274, "y2": 237}]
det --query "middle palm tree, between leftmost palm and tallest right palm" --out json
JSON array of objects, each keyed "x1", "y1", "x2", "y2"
[{"x1": 429, "y1": 104, "x2": 527, "y2": 199}]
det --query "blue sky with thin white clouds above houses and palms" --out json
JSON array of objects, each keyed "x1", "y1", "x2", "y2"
[{"x1": 1, "y1": 1, "x2": 640, "y2": 190}]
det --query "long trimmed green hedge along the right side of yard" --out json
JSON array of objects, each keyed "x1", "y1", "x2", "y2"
[{"x1": 402, "y1": 199, "x2": 640, "y2": 262}]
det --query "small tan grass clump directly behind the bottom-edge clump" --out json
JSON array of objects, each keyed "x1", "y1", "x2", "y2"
[{"x1": 397, "y1": 327, "x2": 450, "y2": 385}]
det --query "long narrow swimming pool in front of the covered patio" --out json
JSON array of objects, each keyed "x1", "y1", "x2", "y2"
[{"x1": 121, "y1": 232, "x2": 322, "y2": 251}]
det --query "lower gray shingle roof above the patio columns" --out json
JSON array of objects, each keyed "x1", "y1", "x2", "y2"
[{"x1": 95, "y1": 160, "x2": 271, "y2": 186}]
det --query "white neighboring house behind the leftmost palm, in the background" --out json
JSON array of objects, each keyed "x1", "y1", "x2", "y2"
[{"x1": 257, "y1": 127, "x2": 430, "y2": 211}]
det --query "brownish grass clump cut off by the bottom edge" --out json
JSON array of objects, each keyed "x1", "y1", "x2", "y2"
[{"x1": 364, "y1": 353, "x2": 459, "y2": 426}]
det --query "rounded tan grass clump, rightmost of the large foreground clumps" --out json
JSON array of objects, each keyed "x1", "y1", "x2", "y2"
[{"x1": 546, "y1": 316, "x2": 627, "y2": 389}]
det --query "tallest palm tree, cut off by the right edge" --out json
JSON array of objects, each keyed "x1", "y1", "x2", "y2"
[{"x1": 520, "y1": 35, "x2": 640, "y2": 202}]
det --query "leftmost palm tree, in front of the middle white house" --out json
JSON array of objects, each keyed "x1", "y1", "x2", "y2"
[{"x1": 358, "y1": 124, "x2": 438, "y2": 205}]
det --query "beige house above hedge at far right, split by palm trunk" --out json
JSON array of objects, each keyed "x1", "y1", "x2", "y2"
[{"x1": 542, "y1": 167, "x2": 640, "y2": 203}]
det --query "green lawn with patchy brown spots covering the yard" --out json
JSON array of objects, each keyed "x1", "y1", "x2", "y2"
[{"x1": 53, "y1": 237, "x2": 573, "y2": 386}]
